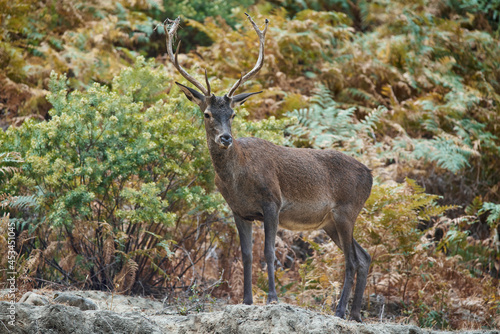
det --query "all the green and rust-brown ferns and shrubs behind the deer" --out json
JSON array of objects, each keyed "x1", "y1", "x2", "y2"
[{"x1": 0, "y1": 0, "x2": 500, "y2": 329}]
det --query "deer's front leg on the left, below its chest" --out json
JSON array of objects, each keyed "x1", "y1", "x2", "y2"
[{"x1": 234, "y1": 214, "x2": 253, "y2": 305}]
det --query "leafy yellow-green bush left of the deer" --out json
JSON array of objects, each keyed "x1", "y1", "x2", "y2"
[{"x1": 2, "y1": 60, "x2": 217, "y2": 287}]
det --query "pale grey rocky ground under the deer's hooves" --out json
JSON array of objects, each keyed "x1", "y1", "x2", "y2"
[{"x1": 0, "y1": 291, "x2": 500, "y2": 334}]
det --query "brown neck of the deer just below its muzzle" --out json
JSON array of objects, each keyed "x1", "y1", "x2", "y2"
[{"x1": 208, "y1": 140, "x2": 240, "y2": 180}]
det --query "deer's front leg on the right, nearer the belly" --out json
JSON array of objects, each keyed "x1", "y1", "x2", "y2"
[{"x1": 263, "y1": 204, "x2": 279, "y2": 304}]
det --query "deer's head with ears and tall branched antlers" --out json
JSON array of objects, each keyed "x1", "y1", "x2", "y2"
[{"x1": 163, "y1": 13, "x2": 269, "y2": 149}]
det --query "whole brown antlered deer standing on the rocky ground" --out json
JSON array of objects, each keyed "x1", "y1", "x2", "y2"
[{"x1": 163, "y1": 13, "x2": 373, "y2": 322}]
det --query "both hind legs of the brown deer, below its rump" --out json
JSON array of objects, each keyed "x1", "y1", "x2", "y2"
[{"x1": 324, "y1": 210, "x2": 370, "y2": 321}]
